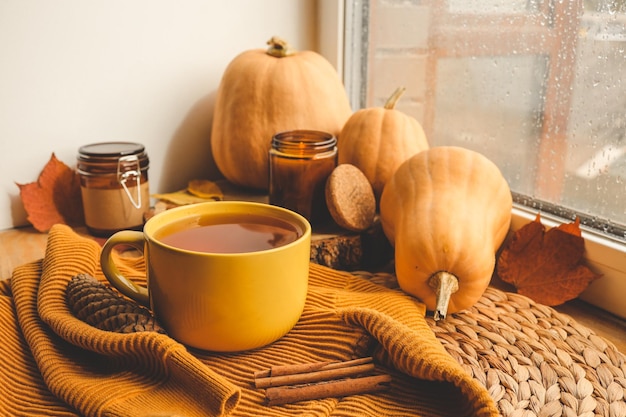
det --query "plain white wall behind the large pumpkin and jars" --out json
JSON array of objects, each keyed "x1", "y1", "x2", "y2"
[{"x1": 0, "y1": 0, "x2": 316, "y2": 229}]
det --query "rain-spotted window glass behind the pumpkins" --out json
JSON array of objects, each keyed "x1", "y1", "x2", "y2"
[{"x1": 344, "y1": 0, "x2": 626, "y2": 240}]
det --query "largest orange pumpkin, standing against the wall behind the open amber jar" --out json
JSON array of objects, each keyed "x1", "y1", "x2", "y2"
[{"x1": 211, "y1": 37, "x2": 352, "y2": 190}]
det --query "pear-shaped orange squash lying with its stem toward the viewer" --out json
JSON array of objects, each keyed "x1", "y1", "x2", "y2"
[{"x1": 380, "y1": 147, "x2": 512, "y2": 320}]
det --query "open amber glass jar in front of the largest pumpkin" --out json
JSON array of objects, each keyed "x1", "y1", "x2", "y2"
[{"x1": 269, "y1": 130, "x2": 337, "y2": 226}]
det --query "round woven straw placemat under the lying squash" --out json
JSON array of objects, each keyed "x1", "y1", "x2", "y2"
[{"x1": 355, "y1": 272, "x2": 626, "y2": 417}]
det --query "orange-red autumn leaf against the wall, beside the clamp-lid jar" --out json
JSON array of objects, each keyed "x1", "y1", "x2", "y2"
[{"x1": 17, "y1": 153, "x2": 84, "y2": 232}]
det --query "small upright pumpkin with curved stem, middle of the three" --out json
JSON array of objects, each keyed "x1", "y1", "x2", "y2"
[{"x1": 337, "y1": 87, "x2": 428, "y2": 201}]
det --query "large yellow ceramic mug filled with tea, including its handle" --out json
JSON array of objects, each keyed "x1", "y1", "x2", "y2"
[{"x1": 100, "y1": 201, "x2": 311, "y2": 352}]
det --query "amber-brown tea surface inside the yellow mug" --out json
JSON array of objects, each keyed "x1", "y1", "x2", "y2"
[{"x1": 155, "y1": 214, "x2": 303, "y2": 253}]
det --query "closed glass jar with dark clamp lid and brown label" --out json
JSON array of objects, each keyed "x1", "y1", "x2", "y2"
[{"x1": 77, "y1": 142, "x2": 150, "y2": 236}]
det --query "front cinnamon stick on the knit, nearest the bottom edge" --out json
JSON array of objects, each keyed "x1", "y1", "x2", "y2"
[{"x1": 265, "y1": 375, "x2": 391, "y2": 406}]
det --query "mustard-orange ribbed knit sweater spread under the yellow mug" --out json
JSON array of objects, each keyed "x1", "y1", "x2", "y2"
[{"x1": 0, "y1": 225, "x2": 499, "y2": 417}]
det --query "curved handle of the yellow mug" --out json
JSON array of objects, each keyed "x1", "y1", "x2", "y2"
[{"x1": 100, "y1": 230, "x2": 150, "y2": 307}]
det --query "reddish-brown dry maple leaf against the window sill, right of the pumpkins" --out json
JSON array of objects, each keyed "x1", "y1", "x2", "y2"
[{"x1": 497, "y1": 214, "x2": 600, "y2": 306}]
